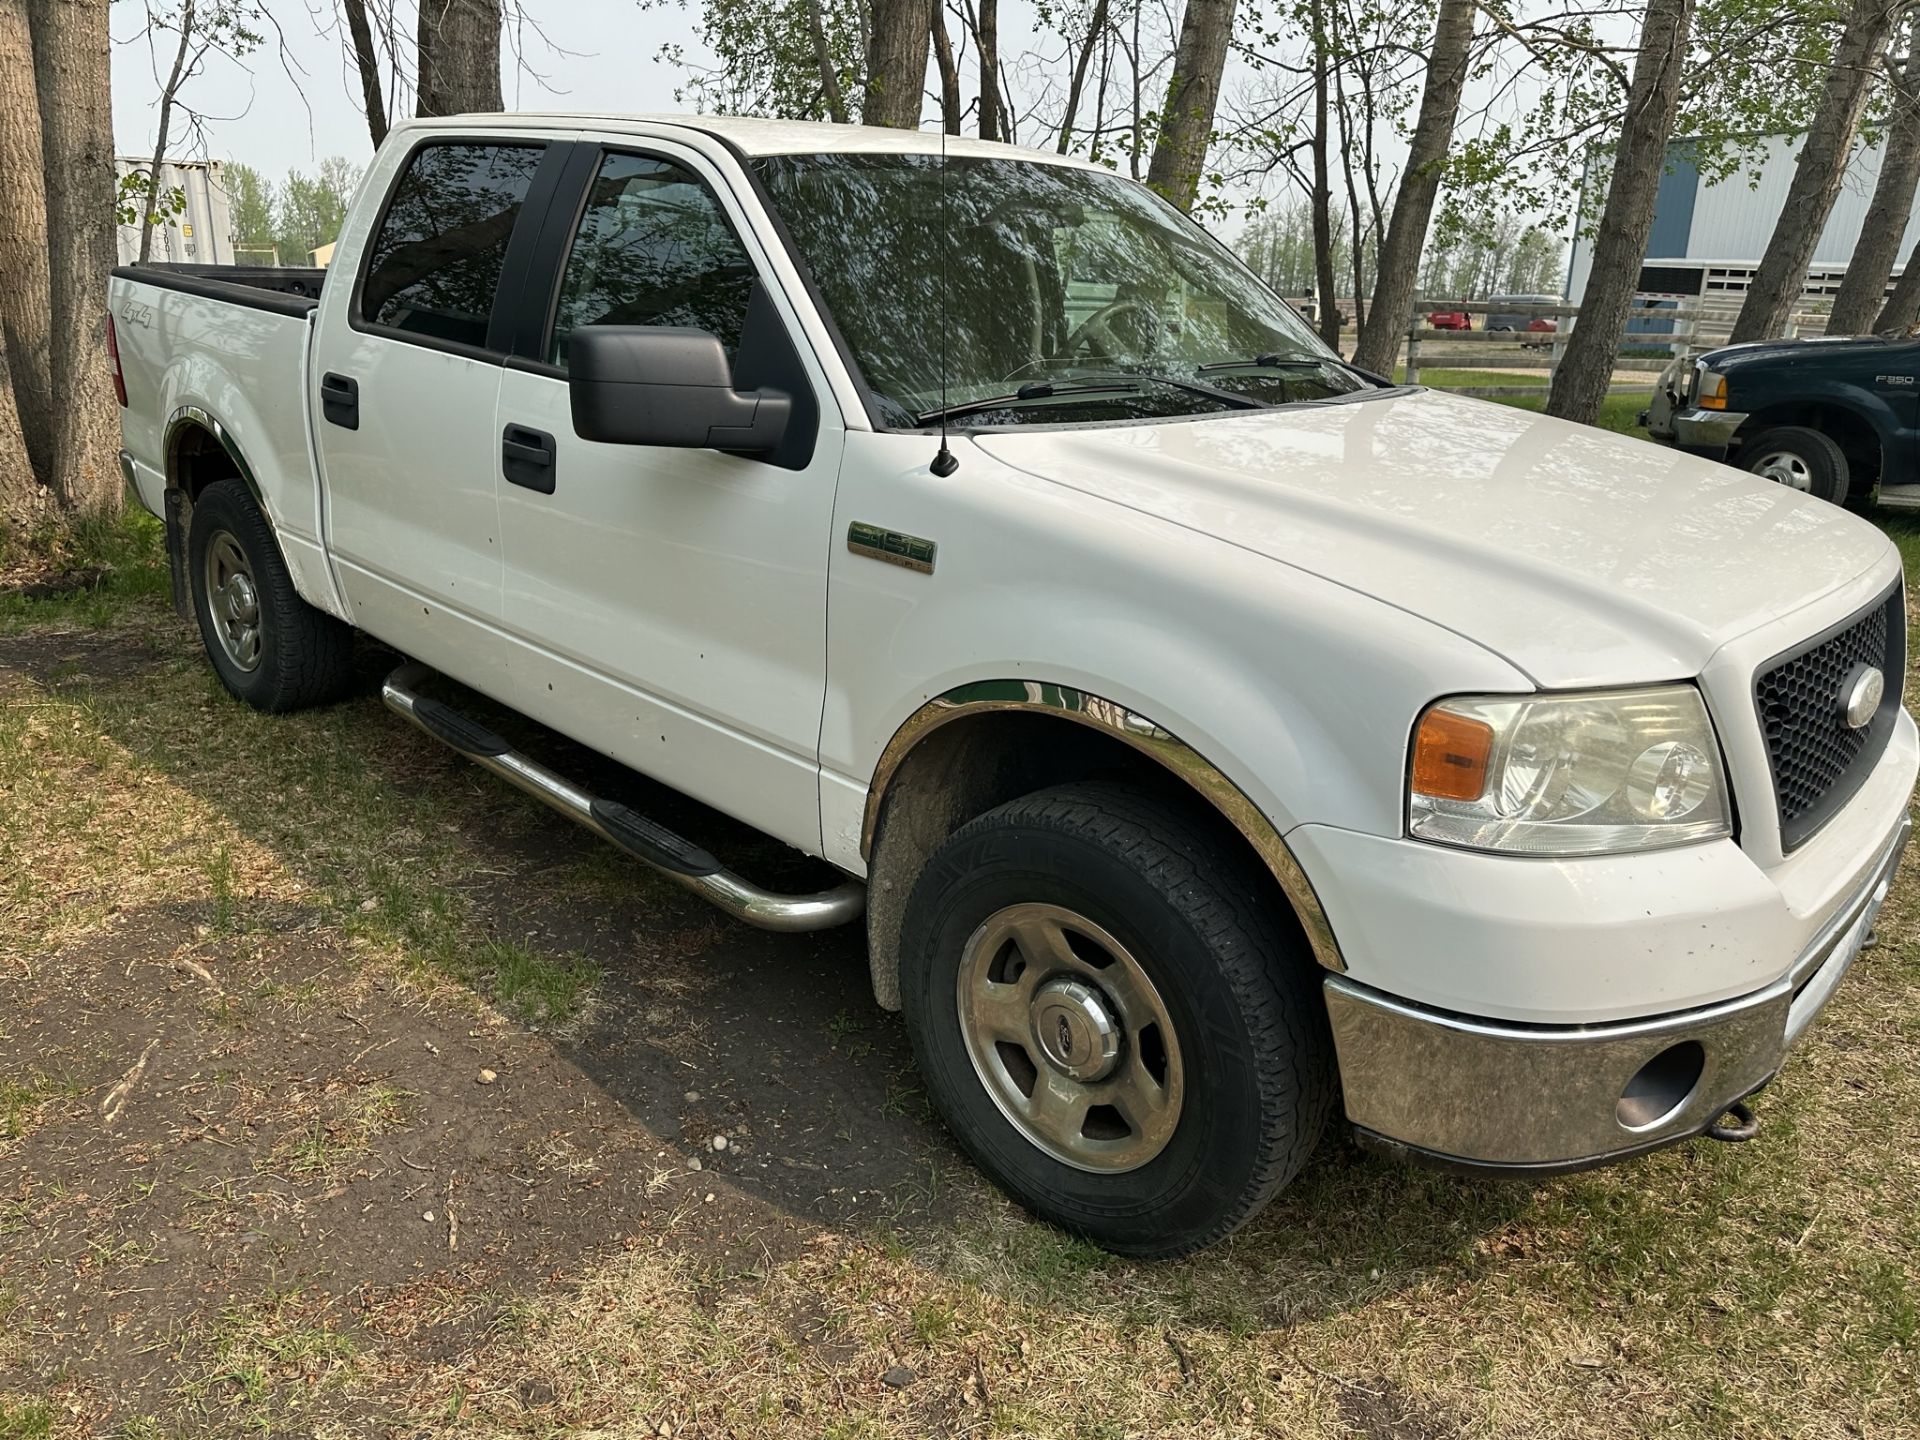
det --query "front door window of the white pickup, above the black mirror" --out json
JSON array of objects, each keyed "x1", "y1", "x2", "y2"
[{"x1": 547, "y1": 156, "x2": 753, "y2": 365}]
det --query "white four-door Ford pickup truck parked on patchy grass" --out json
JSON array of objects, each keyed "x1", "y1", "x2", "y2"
[{"x1": 111, "y1": 115, "x2": 1920, "y2": 1256}]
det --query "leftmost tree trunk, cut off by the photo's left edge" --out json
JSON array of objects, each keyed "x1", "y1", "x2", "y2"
[{"x1": 0, "y1": 0, "x2": 56, "y2": 484}]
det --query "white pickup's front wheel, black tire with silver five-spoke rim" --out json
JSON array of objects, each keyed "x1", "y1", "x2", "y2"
[{"x1": 900, "y1": 783, "x2": 1338, "y2": 1258}]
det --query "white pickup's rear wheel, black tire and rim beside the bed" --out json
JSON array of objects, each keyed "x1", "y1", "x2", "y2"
[{"x1": 186, "y1": 480, "x2": 353, "y2": 714}]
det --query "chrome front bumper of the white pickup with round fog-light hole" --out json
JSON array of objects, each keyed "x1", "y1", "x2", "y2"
[{"x1": 1325, "y1": 816, "x2": 1912, "y2": 1173}]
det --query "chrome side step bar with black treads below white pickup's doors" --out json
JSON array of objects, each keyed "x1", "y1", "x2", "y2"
[{"x1": 380, "y1": 660, "x2": 866, "y2": 933}]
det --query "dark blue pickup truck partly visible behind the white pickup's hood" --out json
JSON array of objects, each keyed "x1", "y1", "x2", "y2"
[{"x1": 1642, "y1": 336, "x2": 1920, "y2": 507}]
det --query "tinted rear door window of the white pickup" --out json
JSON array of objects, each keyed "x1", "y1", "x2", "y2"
[{"x1": 361, "y1": 144, "x2": 543, "y2": 346}]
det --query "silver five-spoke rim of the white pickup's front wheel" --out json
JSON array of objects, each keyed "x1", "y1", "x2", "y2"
[{"x1": 956, "y1": 904, "x2": 1185, "y2": 1173}]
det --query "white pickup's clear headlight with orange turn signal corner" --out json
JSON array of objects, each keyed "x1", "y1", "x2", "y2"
[{"x1": 1407, "y1": 685, "x2": 1732, "y2": 854}]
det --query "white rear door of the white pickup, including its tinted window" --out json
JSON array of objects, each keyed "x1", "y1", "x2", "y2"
[{"x1": 309, "y1": 136, "x2": 568, "y2": 695}]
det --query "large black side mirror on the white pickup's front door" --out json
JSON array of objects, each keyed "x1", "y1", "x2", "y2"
[{"x1": 566, "y1": 324, "x2": 793, "y2": 455}]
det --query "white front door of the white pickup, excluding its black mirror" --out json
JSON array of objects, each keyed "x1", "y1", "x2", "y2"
[{"x1": 493, "y1": 142, "x2": 843, "y2": 852}]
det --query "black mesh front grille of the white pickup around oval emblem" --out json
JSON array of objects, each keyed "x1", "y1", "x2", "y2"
[{"x1": 1753, "y1": 586, "x2": 1907, "y2": 851}]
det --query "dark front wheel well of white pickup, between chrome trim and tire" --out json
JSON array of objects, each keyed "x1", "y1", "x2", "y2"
[{"x1": 866, "y1": 710, "x2": 1306, "y2": 1010}]
